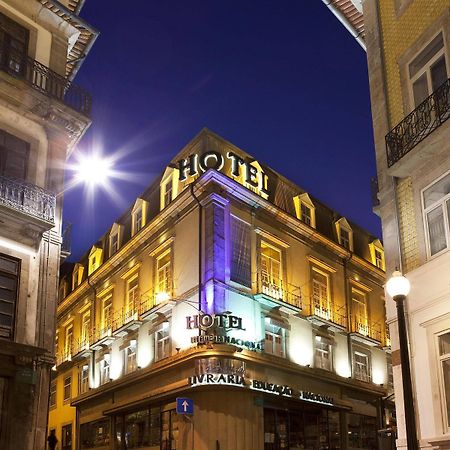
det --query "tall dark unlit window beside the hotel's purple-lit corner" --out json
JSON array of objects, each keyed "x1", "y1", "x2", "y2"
[{"x1": 230, "y1": 217, "x2": 252, "y2": 287}]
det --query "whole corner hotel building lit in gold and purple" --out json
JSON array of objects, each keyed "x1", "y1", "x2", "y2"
[{"x1": 49, "y1": 130, "x2": 390, "y2": 450}]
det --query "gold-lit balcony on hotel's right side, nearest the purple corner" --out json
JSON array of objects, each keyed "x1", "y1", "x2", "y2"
[{"x1": 255, "y1": 274, "x2": 302, "y2": 312}]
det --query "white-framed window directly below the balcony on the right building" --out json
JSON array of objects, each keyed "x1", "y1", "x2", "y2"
[{"x1": 423, "y1": 173, "x2": 450, "y2": 256}]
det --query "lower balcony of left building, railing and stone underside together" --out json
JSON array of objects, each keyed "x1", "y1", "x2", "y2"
[{"x1": 0, "y1": 176, "x2": 56, "y2": 245}]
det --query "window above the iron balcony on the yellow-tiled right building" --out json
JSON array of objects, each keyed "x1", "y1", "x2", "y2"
[{"x1": 409, "y1": 33, "x2": 448, "y2": 107}]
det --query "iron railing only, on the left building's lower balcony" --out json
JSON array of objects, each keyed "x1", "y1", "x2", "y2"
[{"x1": 0, "y1": 176, "x2": 56, "y2": 224}]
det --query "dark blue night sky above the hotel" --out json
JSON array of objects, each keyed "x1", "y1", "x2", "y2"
[{"x1": 64, "y1": 0, "x2": 380, "y2": 259}]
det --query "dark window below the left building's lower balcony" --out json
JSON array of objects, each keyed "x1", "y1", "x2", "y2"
[{"x1": 0, "y1": 255, "x2": 20, "y2": 339}]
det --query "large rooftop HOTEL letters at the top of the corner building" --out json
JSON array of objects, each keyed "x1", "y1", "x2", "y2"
[{"x1": 176, "y1": 150, "x2": 269, "y2": 198}]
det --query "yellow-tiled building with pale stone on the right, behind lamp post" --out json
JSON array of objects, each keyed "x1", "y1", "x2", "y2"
[{"x1": 324, "y1": 0, "x2": 450, "y2": 449}]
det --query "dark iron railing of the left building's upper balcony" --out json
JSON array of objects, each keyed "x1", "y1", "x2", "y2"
[{"x1": 0, "y1": 50, "x2": 92, "y2": 117}]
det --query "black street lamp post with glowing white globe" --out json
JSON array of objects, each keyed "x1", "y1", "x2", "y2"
[{"x1": 386, "y1": 271, "x2": 418, "y2": 450}]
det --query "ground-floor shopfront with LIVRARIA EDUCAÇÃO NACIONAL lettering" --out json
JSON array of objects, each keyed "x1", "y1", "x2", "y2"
[{"x1": 72, "y1": 358, "x2": 383, "y2": 450}]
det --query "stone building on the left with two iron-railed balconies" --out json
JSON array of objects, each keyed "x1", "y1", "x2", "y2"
[{"x1": 0, "y1": 0, "x2": 97, "y2": 450}]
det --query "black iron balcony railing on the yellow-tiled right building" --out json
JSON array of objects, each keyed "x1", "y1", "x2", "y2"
[{"x1": 386, "y1": 79, "x2": 450, "y2": 167}]
